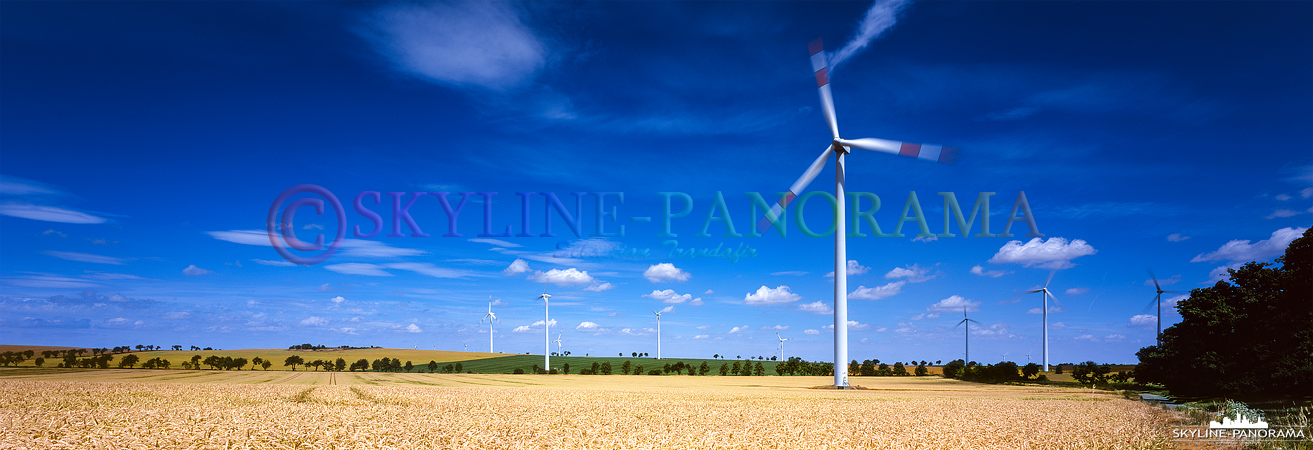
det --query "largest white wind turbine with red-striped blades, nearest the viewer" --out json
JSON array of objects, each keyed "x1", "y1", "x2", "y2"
[{"x1": 758, "y1": 38, "x2": 957, "y2": 388}]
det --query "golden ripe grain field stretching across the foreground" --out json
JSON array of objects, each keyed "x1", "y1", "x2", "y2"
[{"x1": 0, "y1": 369, "x2": 1171, "y2": 449}]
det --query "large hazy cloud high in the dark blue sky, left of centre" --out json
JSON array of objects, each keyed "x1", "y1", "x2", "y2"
[{"x1": 357, "y1": 0, "x2": 546, "y2": 91}]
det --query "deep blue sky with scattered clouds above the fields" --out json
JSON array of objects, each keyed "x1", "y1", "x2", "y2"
[{"x1": 0, "y1": 0, "x2": 1313, "y2": 362}]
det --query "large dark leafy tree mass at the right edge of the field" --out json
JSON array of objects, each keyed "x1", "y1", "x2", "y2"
[{"x1": 1134, "y1": 228, "x2": 1313, "y2": 399}]
